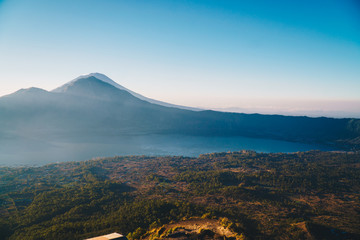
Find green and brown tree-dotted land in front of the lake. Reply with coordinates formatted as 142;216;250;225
0;151;360;240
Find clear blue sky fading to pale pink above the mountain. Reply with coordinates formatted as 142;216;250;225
0;0;360;116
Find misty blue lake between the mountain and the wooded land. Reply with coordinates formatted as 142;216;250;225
0;135;336;166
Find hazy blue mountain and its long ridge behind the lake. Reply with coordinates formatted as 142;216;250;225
0;74;360;165
